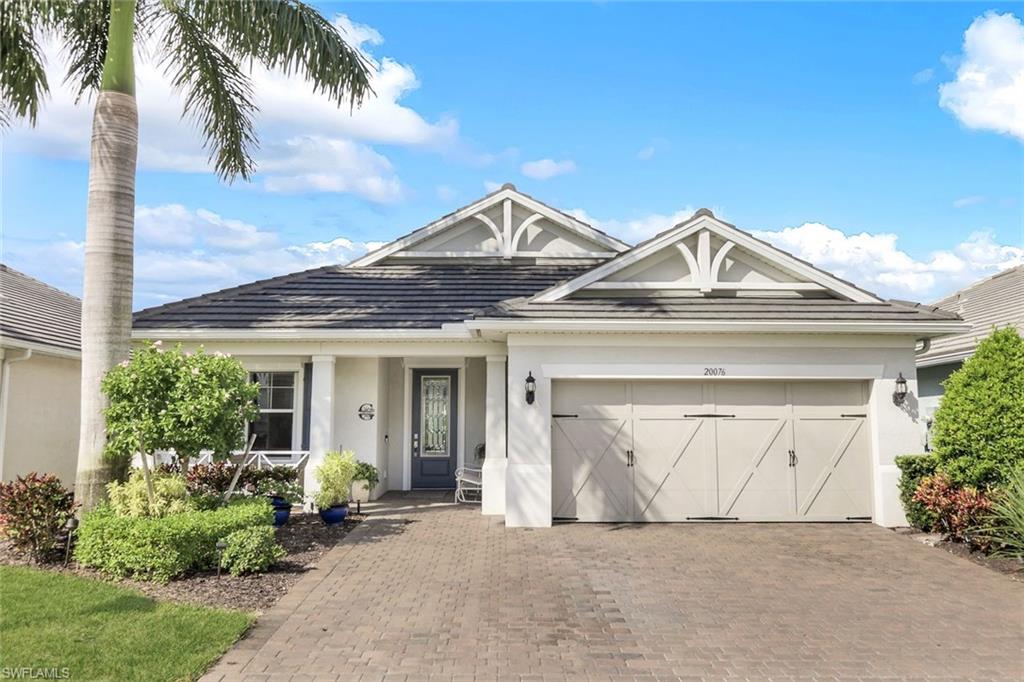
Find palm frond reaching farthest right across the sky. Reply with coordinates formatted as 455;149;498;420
171;0;373;106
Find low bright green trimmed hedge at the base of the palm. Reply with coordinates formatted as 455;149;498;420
75;499;273;583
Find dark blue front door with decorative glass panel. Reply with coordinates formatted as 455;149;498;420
412;370;459;488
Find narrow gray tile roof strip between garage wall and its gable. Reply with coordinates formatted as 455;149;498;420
475;296;957;322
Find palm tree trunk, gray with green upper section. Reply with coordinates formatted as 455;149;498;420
75;0;138;511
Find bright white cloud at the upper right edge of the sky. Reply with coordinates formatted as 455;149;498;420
939;11;1024;140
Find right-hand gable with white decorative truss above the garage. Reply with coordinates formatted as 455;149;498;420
532;209;880;303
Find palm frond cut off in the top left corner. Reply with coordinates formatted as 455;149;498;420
0;0;49;127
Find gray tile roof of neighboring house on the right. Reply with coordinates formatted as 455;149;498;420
918;265;1024;367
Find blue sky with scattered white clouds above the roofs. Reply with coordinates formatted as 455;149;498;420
2;3;1024;308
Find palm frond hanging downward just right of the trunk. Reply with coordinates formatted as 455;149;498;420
163;3;257;179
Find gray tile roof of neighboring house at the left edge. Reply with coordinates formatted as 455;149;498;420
0;263;82;354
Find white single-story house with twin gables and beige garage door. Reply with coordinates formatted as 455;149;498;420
133;184;965;526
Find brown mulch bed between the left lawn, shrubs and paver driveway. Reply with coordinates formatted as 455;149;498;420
0;511;365;613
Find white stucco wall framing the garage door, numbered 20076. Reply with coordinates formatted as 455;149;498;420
506;334;921;526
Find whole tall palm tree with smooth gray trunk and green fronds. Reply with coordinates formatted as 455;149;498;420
0;0;373;509
